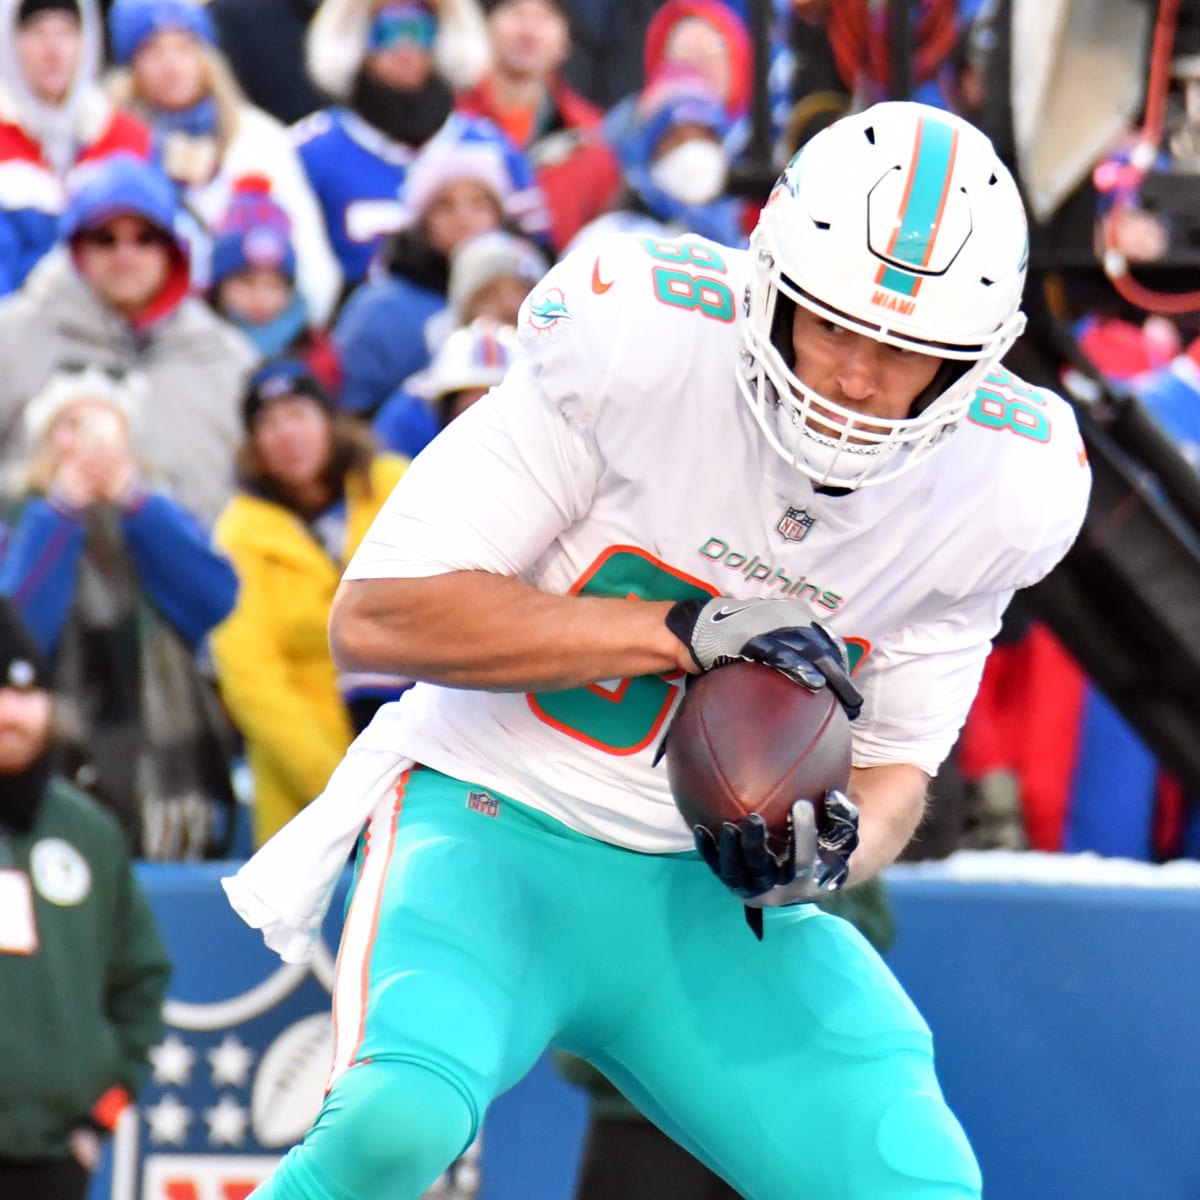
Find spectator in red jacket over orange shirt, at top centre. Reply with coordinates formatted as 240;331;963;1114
455;0;620;252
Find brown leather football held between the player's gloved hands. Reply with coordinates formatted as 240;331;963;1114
666;662;851;835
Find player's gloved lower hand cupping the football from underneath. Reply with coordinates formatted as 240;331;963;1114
692;788;858;908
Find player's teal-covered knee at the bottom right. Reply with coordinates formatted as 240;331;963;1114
856;1092;983;1200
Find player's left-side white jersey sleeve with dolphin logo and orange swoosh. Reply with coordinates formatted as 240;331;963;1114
346;235;733;578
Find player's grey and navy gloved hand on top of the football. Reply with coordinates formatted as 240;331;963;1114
666;596;863;720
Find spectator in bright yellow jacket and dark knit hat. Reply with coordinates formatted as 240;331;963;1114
211;360;407;845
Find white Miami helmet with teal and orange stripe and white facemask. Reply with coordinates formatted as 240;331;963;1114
738;101;1028;488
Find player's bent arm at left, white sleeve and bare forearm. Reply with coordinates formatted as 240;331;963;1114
330;247;696;691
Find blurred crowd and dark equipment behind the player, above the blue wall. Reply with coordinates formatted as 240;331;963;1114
0;0;1200;860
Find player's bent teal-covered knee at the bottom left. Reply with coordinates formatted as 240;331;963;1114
308;1060;476;1198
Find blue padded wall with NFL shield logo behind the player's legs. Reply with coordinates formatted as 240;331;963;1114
89;856;1200;1200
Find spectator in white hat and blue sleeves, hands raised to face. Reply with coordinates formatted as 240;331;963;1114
0;365;238;859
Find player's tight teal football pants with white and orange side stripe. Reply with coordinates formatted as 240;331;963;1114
254;769;980;1200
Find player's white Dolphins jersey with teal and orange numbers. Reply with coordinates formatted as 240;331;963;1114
346;236;1090;852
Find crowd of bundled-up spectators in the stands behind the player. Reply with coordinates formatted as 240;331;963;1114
0;0;1198;902
